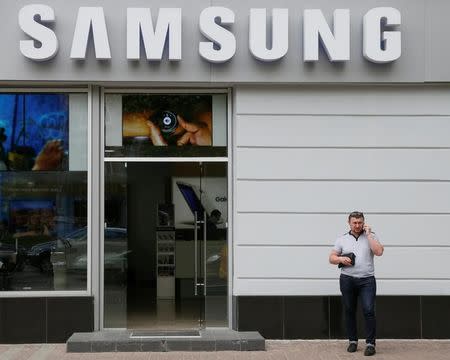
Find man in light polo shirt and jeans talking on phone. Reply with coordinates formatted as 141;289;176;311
329;211;384;356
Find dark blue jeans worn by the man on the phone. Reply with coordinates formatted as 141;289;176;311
339;274;377;345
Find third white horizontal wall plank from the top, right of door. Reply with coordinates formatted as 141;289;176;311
236;148;450;181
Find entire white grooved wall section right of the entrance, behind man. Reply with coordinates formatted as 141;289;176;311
233;85;450;295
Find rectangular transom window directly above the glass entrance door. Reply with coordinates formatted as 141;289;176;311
105;94;227;157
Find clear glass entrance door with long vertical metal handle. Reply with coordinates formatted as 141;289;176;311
103;161;228;330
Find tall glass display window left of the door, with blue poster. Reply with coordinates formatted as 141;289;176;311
0;93;88;292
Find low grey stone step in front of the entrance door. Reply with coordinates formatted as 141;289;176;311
66;328;266;353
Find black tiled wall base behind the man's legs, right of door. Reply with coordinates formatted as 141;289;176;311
233;296;450;339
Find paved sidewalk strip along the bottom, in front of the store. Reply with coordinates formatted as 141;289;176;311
0;340;450;360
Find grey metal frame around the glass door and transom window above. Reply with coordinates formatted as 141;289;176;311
96;86;233;330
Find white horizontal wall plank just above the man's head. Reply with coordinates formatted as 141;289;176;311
236;181;450;213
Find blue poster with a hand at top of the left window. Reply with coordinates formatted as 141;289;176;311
0;93;69;171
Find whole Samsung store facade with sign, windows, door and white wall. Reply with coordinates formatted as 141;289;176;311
0;0;450;343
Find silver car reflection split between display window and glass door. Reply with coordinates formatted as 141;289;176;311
51;227;129;271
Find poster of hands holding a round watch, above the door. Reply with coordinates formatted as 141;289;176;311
122;94;213;147
